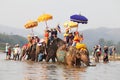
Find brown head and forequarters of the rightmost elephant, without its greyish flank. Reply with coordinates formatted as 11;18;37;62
66;46;89;66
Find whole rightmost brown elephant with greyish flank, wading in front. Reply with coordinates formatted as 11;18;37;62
57;46;90;66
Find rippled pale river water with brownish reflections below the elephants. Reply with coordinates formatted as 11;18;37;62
0;53;120;80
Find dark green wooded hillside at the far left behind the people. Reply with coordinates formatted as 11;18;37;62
0;33;27;50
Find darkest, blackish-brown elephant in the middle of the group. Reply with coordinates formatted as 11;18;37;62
46;38;65;62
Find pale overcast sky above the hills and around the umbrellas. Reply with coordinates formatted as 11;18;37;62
0;0;120;32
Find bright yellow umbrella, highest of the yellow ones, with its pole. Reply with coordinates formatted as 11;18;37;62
37;14;53;28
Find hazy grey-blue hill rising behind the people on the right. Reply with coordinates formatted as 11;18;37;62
81;27;120;46
